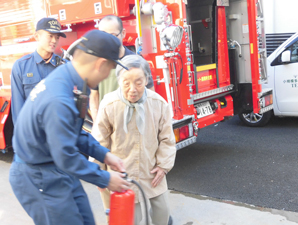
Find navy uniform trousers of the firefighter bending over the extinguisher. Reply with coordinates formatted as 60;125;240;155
9;160;95;225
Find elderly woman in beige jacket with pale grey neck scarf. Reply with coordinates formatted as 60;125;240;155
92;55;176;225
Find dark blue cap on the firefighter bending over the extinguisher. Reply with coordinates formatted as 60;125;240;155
77;30;128;70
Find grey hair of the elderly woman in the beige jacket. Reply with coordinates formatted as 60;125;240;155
116;55;151;81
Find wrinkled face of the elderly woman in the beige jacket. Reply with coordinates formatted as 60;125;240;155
119;68;147;103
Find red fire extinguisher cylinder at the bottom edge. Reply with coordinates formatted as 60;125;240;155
109;190;135;225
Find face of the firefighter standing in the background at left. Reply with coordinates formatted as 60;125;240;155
35;30;60;53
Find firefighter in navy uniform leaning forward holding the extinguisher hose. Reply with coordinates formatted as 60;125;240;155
9;30;129;225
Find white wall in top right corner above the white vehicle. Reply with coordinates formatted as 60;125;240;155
263;0;298;34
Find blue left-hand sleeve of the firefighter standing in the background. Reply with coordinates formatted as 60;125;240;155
11;61;26;124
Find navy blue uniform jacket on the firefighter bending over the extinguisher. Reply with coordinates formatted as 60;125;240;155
13;62;110;188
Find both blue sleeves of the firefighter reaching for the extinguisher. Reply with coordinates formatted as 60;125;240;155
42;99;110;188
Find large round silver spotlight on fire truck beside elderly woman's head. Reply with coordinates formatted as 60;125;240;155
160;24;183;51
